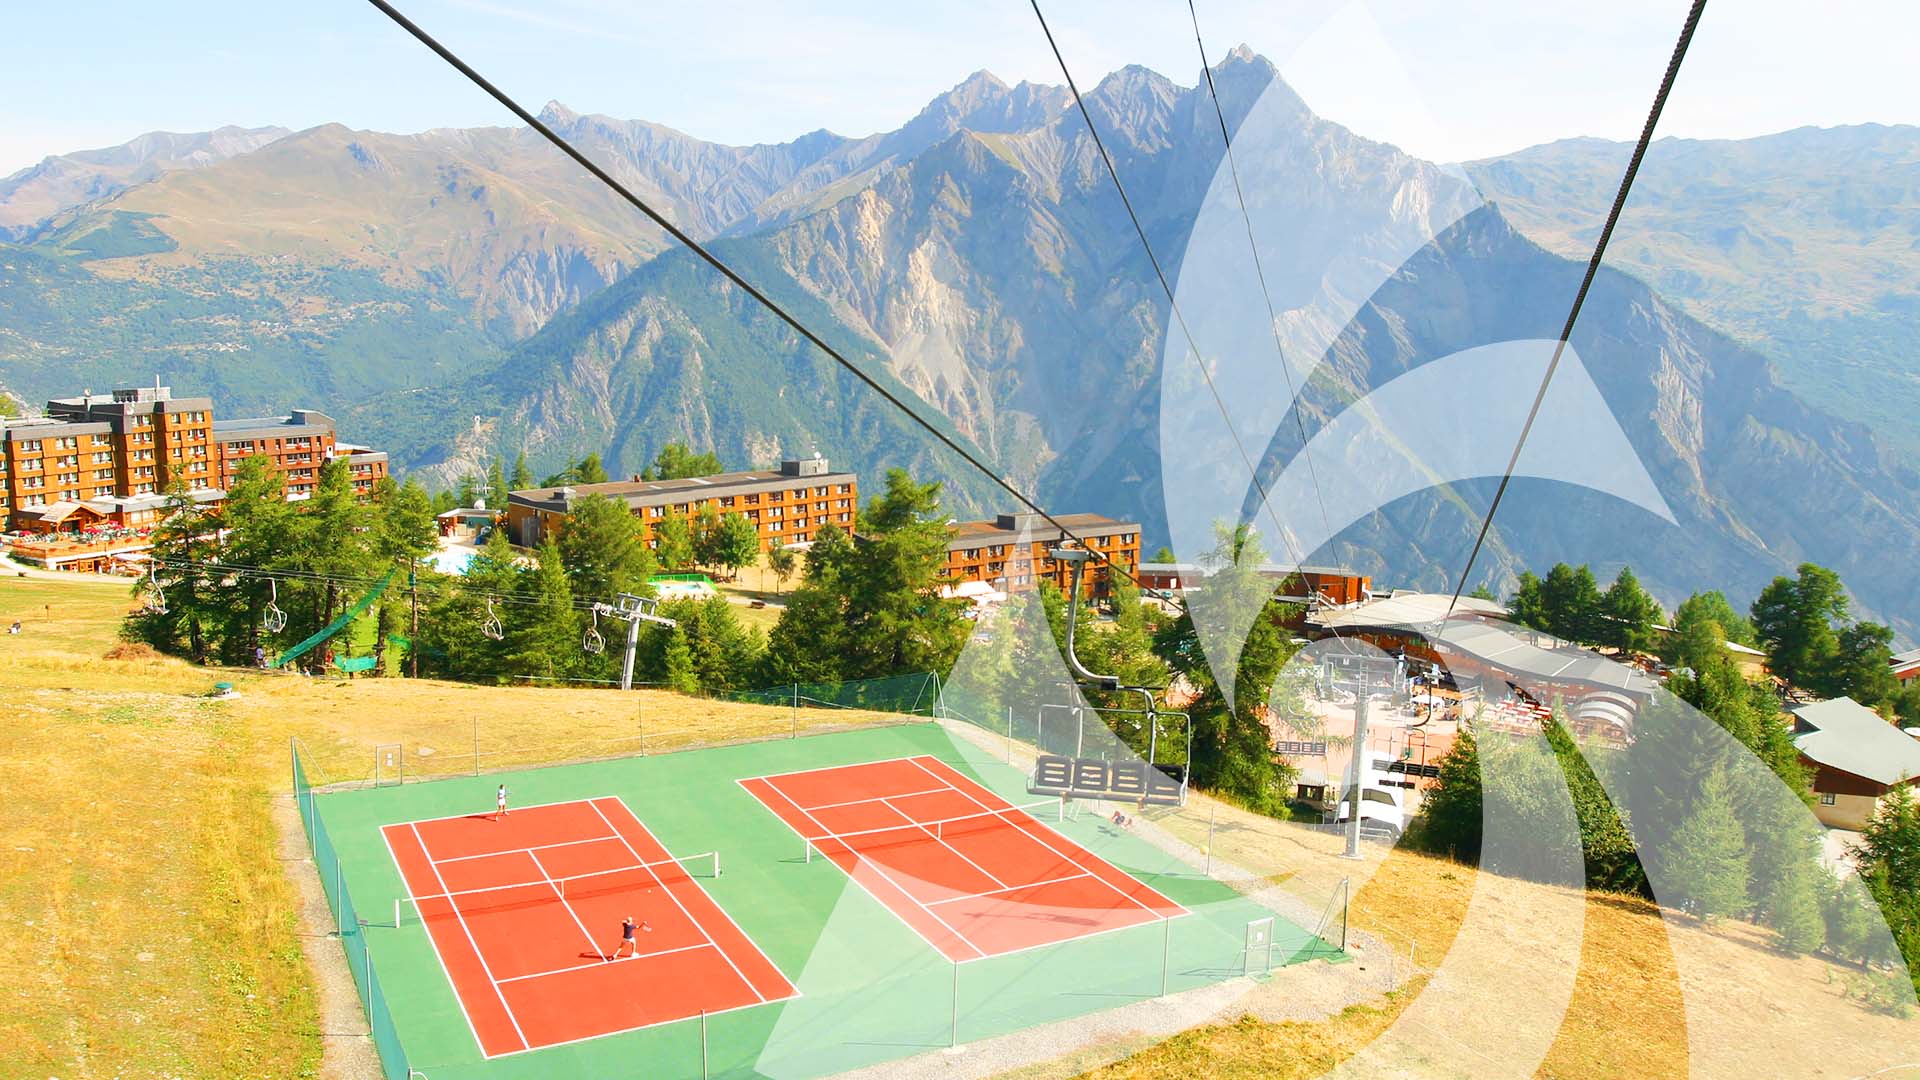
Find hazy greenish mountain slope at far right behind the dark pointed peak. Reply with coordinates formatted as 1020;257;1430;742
1469;125;1920;455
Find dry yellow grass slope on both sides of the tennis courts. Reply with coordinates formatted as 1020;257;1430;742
0;578;1920;1080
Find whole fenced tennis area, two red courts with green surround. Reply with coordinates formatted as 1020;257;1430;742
307;723;1336;1080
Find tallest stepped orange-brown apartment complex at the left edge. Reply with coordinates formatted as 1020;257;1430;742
0;386;388;532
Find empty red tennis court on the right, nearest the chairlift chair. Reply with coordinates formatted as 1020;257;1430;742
741;757;1187;963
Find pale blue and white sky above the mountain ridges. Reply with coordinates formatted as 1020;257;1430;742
0;0;1920;175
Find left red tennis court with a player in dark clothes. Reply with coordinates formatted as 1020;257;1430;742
382;798;795;1057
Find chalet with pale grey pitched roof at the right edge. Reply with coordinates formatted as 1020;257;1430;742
1793;698;1920;828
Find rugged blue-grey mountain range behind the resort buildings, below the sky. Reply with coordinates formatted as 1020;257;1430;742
0;48;1920;634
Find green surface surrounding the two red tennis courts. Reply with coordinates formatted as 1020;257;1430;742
303;723;1334;1080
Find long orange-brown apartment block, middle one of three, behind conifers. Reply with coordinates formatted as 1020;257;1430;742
507;457;860;552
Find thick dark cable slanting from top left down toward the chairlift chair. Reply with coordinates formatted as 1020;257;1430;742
367;0;1140;586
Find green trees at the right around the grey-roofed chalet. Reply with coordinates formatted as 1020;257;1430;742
1407;563;1920;1003
